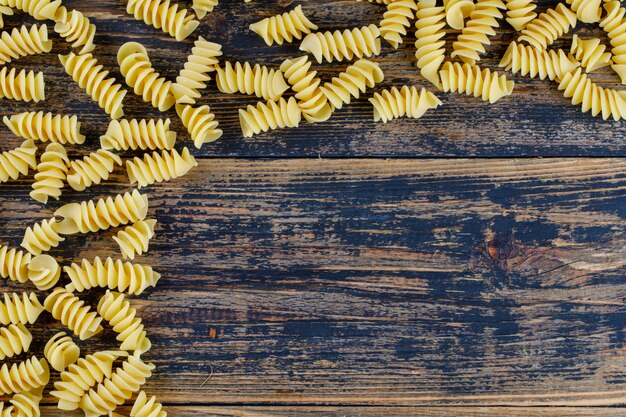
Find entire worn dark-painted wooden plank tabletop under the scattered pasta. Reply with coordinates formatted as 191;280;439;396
0;0;626;417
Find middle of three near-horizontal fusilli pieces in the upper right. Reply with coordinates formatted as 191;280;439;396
499;42;580;81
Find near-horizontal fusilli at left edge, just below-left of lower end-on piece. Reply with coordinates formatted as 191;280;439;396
0;356;50;394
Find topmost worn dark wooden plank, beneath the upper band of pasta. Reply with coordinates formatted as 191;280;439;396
0;0;626;157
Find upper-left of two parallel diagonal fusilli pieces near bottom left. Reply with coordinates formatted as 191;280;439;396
50;350;128;411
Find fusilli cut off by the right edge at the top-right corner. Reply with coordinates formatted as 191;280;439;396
600;0;626;84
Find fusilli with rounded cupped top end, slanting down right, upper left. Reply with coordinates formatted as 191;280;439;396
117;42;176;111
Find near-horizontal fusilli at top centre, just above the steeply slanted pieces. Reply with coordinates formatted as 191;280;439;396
300;25;381;64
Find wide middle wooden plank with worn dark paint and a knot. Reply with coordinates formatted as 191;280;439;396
0;159;626;406
